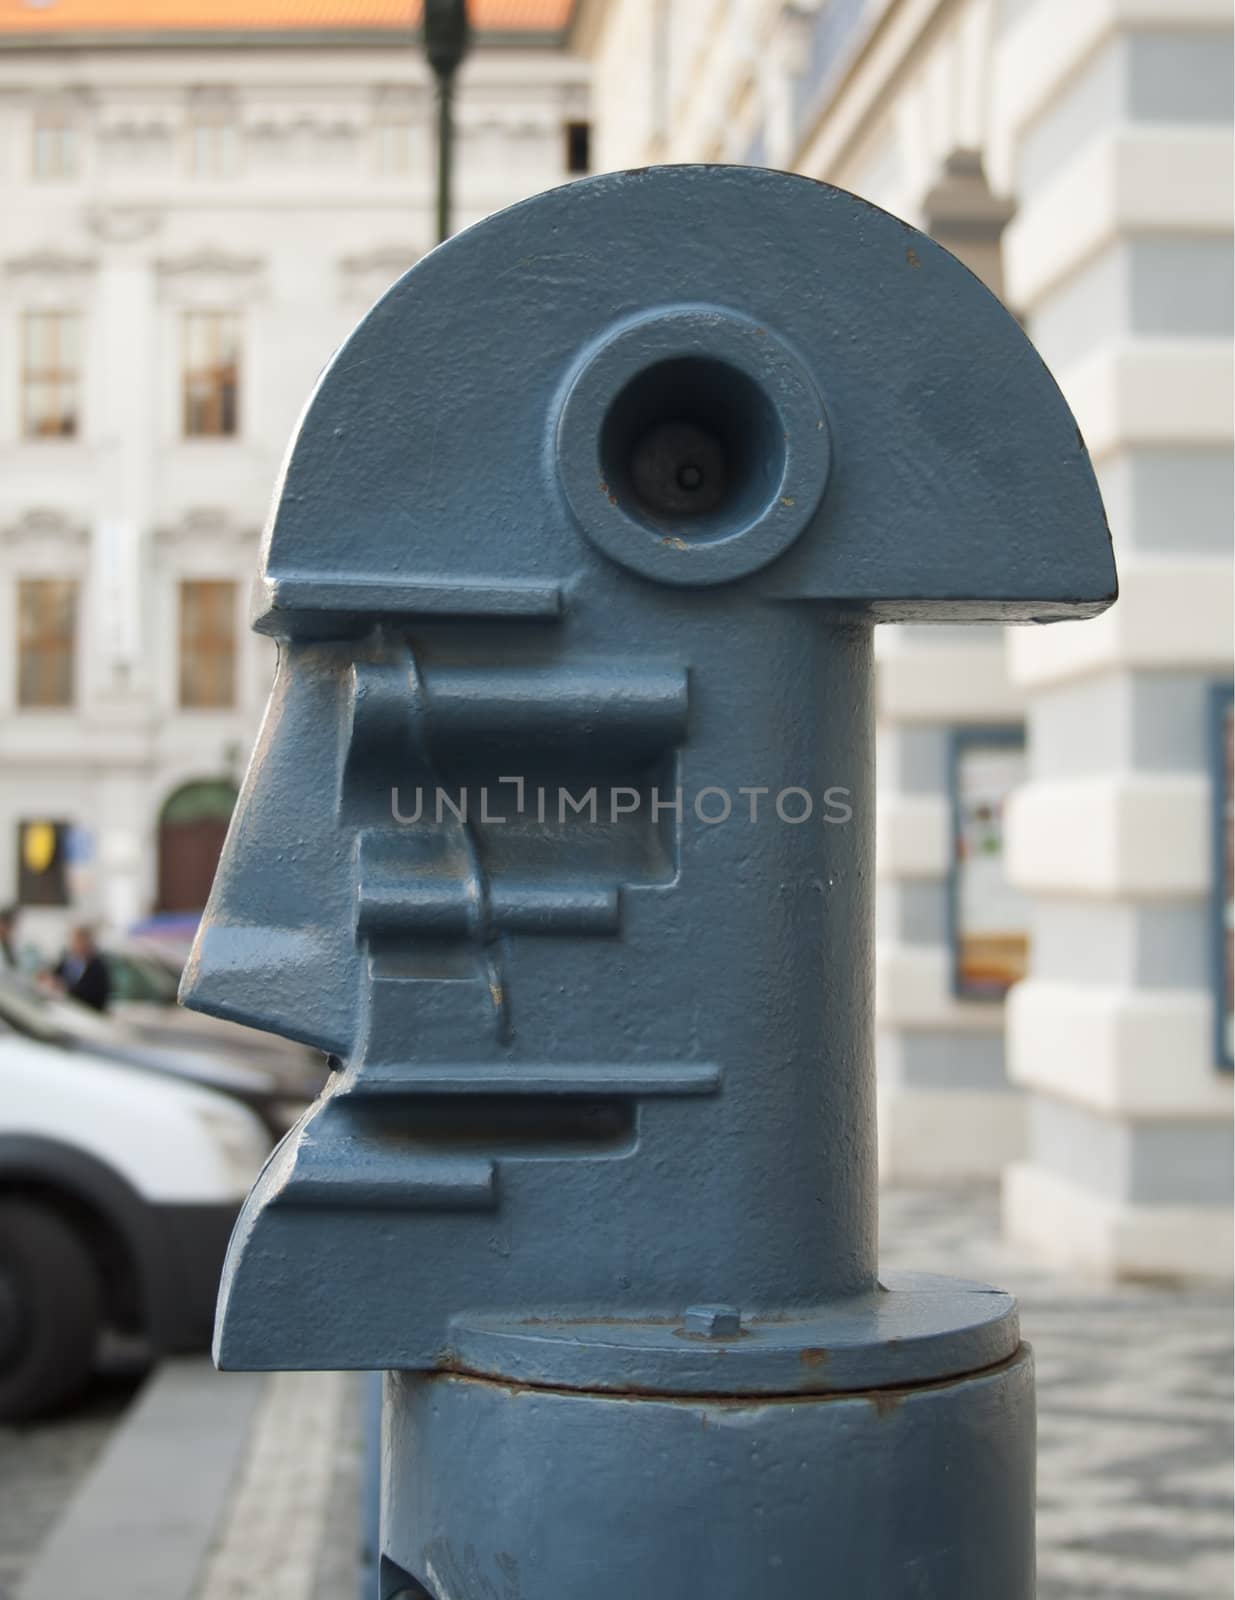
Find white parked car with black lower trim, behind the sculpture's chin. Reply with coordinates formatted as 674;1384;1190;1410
0;979;272;1421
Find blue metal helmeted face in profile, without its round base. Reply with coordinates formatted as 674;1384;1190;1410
184;168;1115;1382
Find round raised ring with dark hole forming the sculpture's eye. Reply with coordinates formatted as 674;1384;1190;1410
557;306;830;584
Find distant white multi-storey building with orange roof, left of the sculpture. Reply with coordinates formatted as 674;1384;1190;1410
0;0;589;942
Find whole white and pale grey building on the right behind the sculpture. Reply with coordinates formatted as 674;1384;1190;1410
573;0;1232;1275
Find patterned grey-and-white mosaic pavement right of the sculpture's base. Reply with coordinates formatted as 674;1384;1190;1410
881;1186;1232;1600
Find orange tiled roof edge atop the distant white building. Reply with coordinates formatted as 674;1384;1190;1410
0;0;573;37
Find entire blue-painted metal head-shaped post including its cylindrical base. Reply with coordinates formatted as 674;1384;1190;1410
186;168;1115;1600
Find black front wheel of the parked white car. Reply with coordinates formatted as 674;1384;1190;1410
0;1200;102;1422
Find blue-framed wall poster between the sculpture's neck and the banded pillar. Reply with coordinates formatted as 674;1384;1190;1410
949;728;1029;1000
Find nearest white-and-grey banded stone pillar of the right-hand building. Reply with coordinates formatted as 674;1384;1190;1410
992;0;1232;1275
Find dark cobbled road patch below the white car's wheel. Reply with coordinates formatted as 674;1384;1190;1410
0;1362;142;1600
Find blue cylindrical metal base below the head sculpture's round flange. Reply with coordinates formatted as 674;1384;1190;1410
382;1346;1033;1600
